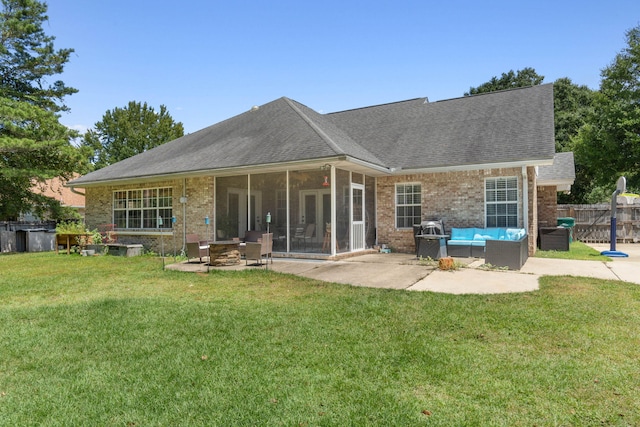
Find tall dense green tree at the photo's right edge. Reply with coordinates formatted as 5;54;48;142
575;26;640;198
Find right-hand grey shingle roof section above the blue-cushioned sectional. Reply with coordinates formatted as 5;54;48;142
328;84;555;169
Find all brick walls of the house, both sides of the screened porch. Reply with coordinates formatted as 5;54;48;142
85;168;544;254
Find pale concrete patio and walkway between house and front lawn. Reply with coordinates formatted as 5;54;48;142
167;244;640;294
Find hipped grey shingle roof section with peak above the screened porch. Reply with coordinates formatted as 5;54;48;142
73;97;382;185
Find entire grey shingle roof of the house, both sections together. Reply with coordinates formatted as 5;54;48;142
71;85;554;187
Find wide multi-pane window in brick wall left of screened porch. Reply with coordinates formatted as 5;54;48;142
113;188;173;229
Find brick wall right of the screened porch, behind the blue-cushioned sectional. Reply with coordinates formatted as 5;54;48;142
377;168;537;254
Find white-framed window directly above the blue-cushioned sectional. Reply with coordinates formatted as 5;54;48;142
484;177;519;227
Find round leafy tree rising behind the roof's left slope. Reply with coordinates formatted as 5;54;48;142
82;101;184;169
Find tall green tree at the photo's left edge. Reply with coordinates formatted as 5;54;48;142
0;0;87;220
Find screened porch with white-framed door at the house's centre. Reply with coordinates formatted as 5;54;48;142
212;165;375;256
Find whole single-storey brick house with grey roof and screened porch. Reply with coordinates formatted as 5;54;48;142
68;85;556;256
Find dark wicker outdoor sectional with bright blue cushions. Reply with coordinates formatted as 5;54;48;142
447;228;529;270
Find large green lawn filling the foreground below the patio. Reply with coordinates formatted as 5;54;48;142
0;254;640;426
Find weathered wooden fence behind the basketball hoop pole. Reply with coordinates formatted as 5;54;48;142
558;201;640;243
